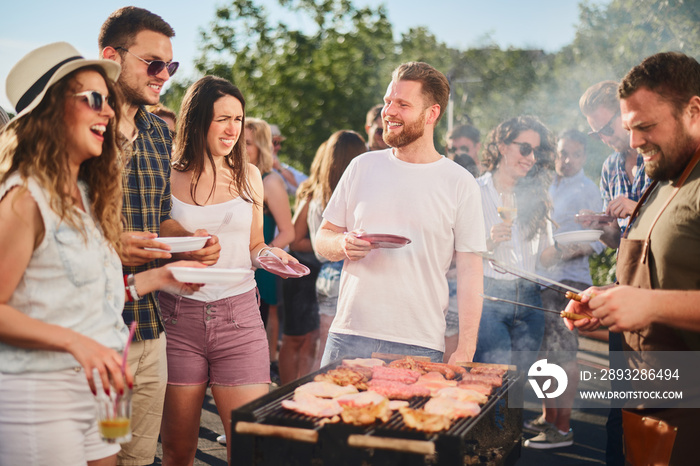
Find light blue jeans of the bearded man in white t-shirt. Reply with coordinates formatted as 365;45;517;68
321;333;443;366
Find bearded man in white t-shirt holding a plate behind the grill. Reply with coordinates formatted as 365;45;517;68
316;62;486;365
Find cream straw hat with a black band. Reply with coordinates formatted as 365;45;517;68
5;42;121;118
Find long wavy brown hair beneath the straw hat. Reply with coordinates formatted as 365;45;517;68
0;66;122;251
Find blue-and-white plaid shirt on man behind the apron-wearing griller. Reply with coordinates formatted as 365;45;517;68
600;152;651;233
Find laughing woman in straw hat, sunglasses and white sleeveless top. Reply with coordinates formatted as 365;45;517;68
0;42;198;465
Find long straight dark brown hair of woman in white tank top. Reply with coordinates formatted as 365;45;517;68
173;76;253;205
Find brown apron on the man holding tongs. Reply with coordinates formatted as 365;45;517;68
617;147;700;465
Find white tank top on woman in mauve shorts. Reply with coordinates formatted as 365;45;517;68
172;196;255;302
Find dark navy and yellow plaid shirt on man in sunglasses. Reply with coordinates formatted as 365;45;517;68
122;107;172;341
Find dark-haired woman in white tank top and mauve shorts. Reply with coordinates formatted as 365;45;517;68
159;76;296;465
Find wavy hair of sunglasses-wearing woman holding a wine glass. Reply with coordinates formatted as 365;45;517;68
482;115;556;240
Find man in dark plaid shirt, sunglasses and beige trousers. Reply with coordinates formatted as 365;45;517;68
99;7;221;465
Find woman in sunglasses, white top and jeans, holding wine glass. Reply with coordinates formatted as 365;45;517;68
474;116;560;370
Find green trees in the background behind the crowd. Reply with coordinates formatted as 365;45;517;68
164;0;700;284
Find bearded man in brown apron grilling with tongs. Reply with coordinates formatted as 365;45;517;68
567;52;700;465
